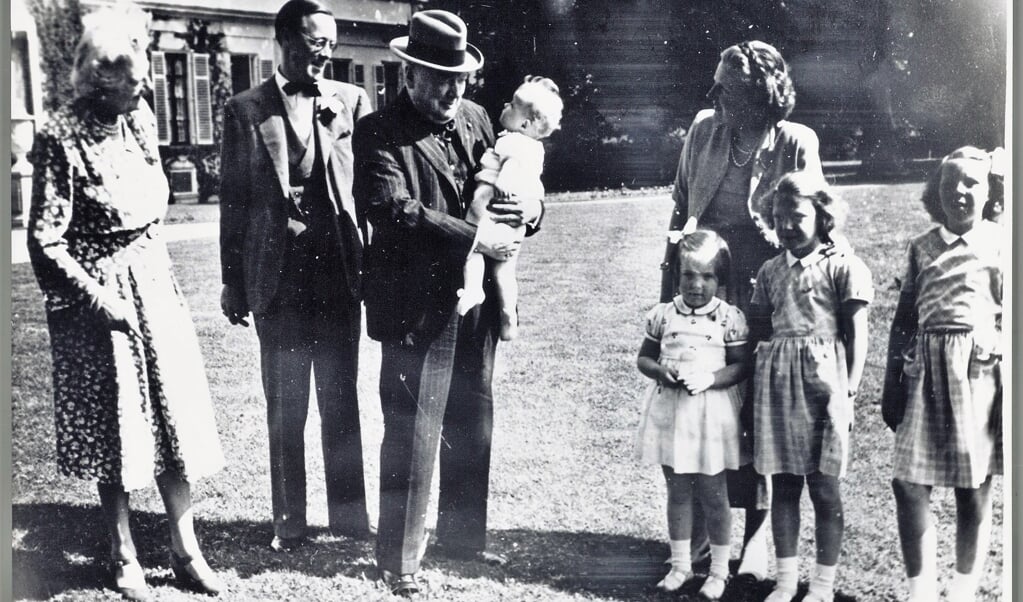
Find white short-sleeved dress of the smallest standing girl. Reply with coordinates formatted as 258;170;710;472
635;296;749;475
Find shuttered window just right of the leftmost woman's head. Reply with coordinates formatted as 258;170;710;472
150;51;213;144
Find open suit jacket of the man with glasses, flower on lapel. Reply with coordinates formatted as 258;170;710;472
220;78;369;323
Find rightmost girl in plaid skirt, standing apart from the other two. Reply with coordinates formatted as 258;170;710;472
882;147;1008;602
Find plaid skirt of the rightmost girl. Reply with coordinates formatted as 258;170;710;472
894;332;1003;488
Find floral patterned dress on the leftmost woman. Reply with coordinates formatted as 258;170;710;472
29;101;224;490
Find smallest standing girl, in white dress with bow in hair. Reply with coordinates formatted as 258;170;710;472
636;230;749;600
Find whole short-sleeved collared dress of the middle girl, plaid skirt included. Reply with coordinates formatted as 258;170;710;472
752;246;874;477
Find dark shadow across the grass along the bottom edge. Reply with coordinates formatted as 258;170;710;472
12;504;855;602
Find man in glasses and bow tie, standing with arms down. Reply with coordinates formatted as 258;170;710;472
220;0;370;552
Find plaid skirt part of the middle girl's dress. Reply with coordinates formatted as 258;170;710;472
753;336;852;477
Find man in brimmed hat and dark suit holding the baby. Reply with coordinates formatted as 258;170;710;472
353;10;542;595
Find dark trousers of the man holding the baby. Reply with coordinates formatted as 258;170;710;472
376;311;496;573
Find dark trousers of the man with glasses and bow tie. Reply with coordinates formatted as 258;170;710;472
256;231;369;538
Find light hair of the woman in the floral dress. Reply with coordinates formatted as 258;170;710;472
71;4;149;98
